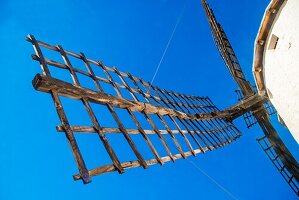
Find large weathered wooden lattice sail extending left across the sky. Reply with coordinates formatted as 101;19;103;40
27;35;241;183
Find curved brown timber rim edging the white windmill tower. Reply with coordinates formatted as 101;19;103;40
252;0;288;96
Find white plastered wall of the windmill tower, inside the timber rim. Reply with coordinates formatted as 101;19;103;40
264;0;299;143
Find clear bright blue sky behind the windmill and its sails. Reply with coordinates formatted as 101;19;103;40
0;0;299;200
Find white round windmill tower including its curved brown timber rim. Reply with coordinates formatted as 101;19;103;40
253;0;299;143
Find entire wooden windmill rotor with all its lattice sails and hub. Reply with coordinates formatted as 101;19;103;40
27;0;299;194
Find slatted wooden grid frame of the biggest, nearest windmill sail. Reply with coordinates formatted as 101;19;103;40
27;35;241;183
